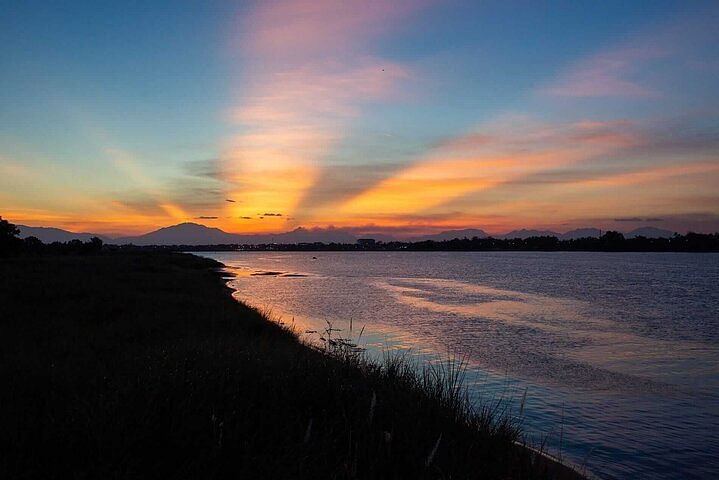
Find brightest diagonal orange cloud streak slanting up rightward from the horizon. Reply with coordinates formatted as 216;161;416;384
325;116;638;221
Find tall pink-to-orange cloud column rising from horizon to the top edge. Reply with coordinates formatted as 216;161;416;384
223;0;417;230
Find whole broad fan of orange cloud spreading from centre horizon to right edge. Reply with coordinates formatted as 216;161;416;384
302;110;719;231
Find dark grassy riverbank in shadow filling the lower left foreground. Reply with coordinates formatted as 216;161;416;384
0;253;574;479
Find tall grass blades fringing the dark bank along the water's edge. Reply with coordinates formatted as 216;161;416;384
278;311;581;478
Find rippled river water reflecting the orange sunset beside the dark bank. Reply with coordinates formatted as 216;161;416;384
201;252;719;479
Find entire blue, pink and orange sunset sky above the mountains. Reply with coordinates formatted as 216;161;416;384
0;0;719;237
